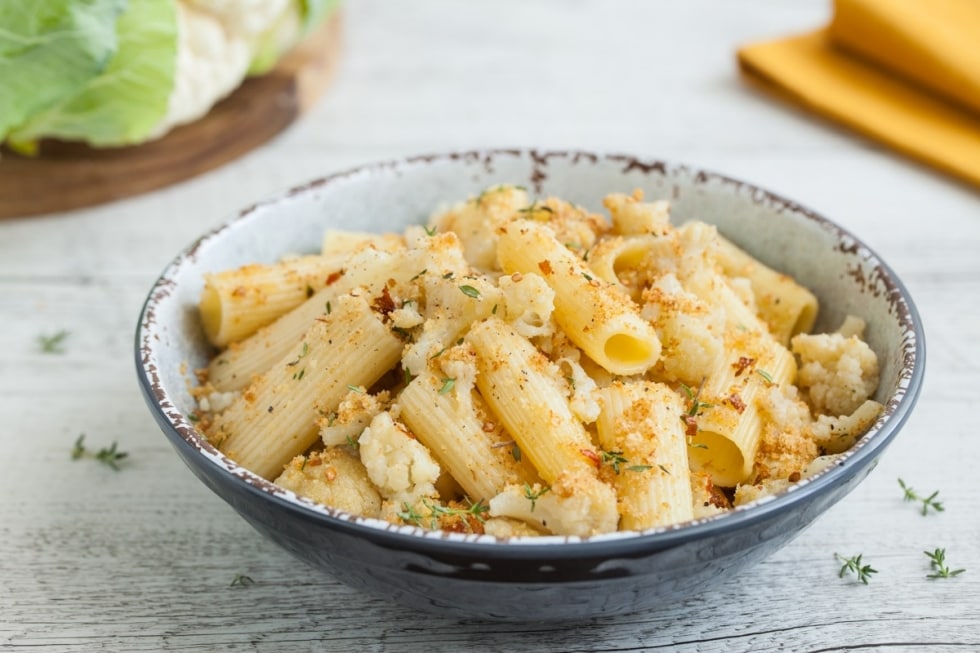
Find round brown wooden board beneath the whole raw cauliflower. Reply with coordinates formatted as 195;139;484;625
0;12;341;218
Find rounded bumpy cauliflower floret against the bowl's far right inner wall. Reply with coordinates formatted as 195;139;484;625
791;333;878;416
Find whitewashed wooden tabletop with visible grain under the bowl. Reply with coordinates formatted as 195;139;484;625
0;0;980;652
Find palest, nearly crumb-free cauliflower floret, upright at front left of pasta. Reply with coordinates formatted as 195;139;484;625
358;413;440;505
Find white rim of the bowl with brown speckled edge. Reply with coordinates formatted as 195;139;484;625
136;148;925;560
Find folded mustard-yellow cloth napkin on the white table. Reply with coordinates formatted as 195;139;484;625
738;0;980;186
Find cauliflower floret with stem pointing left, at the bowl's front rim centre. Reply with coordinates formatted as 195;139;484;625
490;472;619;537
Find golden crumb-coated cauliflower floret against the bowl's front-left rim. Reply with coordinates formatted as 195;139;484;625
275;447;381;517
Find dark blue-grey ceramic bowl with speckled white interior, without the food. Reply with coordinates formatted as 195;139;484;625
136;150;925;621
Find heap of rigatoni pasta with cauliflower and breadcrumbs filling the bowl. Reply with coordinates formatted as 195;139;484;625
195;185;881;536
